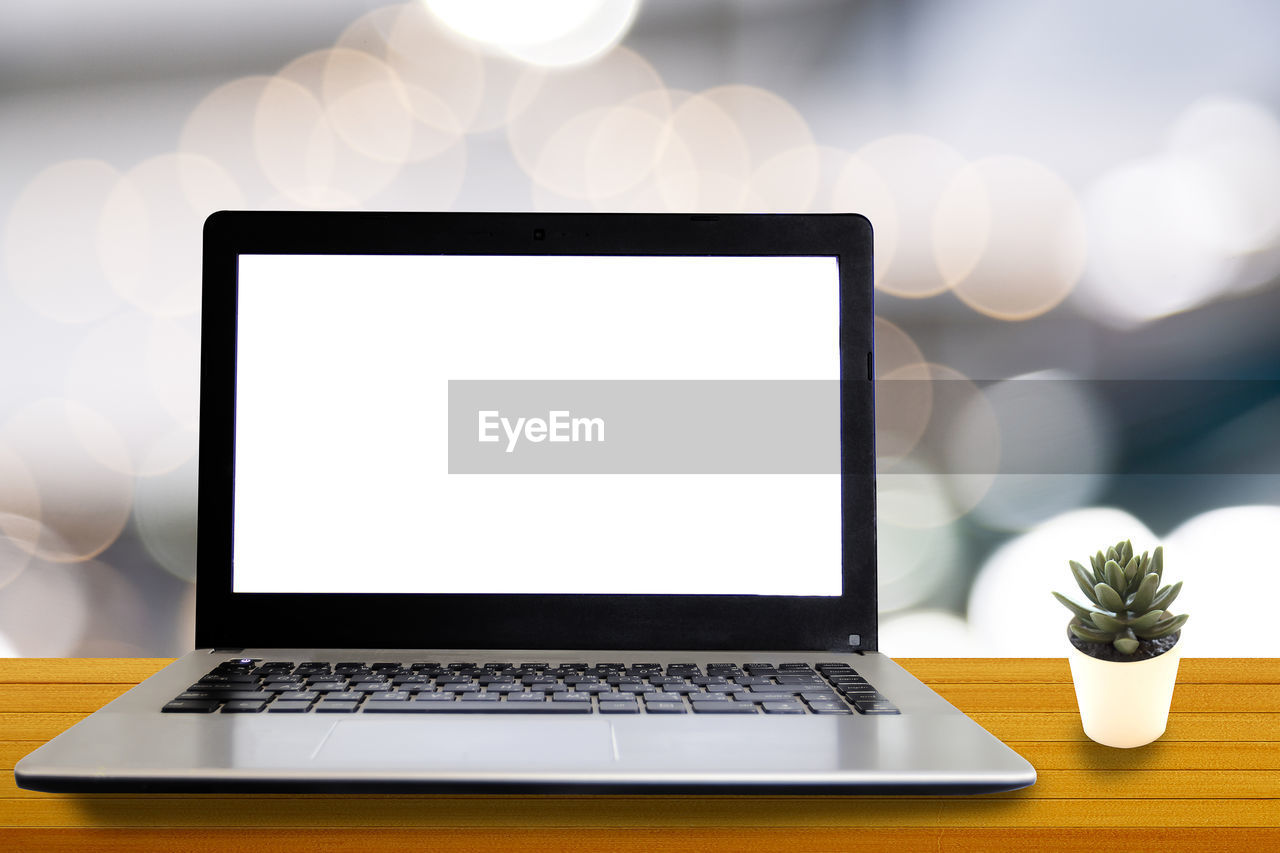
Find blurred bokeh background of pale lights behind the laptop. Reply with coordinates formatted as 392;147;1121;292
0;0;1280;656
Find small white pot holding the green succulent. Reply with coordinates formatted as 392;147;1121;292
1068;637;1183;748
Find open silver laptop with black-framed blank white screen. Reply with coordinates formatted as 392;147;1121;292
15;211;1036;793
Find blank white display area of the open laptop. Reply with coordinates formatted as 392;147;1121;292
232;254;842;597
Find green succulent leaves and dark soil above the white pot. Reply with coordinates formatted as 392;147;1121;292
1053;539;1187;654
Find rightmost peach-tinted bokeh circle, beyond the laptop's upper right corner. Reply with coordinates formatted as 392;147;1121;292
933;156;1085;320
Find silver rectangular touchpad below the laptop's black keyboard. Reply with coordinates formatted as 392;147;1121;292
312;716;617;771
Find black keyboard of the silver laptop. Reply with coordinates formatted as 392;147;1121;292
163;658;899;715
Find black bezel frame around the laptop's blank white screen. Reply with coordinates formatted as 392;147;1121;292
196;211;877;651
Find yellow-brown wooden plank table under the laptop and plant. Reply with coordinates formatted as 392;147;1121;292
0;658;1280;853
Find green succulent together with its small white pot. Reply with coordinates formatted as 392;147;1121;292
1053;539;1187;747
